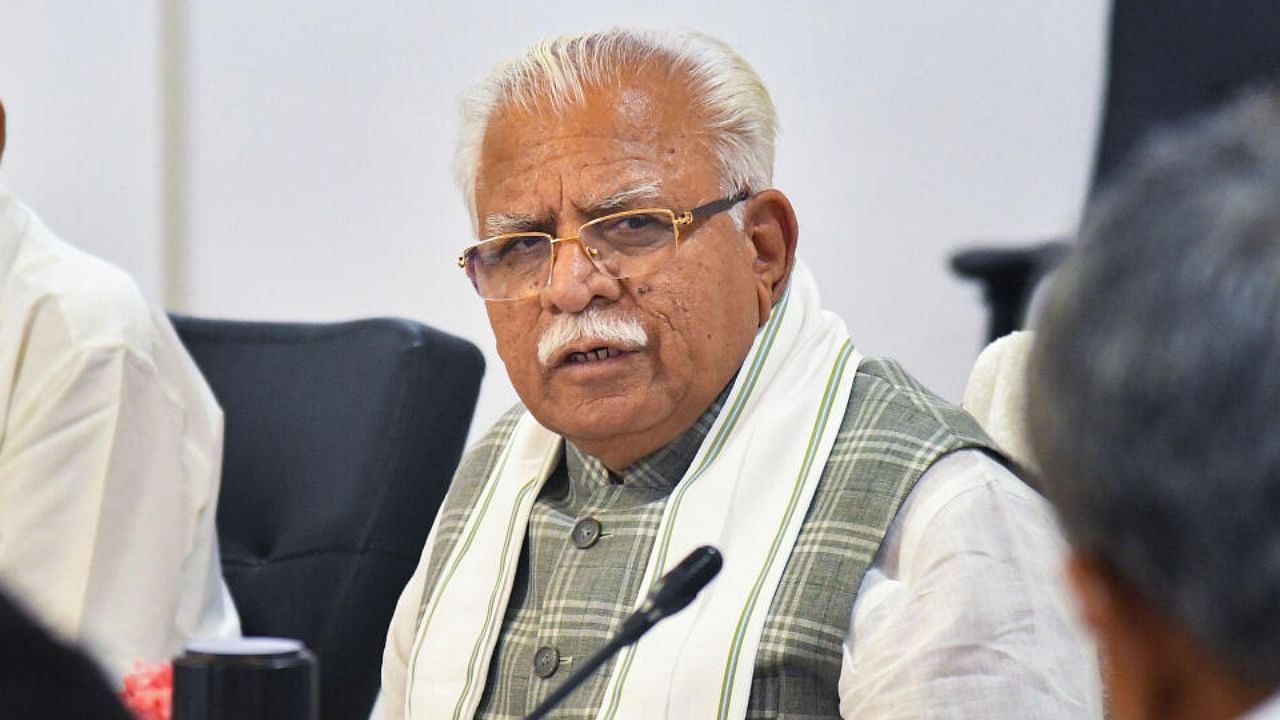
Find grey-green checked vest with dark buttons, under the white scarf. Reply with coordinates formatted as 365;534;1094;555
419;359;995;720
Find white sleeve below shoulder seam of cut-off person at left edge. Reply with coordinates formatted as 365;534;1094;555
0;338;196;680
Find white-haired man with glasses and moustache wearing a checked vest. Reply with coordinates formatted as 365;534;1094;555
384;31;1098;720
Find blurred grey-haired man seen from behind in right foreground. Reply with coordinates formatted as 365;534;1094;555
1030;91;1280;720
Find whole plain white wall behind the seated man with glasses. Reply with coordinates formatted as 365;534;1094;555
0;0;1106;438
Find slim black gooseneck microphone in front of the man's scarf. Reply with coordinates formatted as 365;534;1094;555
525;544;724;720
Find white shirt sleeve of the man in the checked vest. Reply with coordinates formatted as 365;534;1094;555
840;450;1102;720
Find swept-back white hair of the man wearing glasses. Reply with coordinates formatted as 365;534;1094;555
456;28;777;225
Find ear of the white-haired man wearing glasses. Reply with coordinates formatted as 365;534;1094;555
742;190;799;325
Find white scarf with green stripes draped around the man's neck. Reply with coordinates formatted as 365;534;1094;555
406;261;860;720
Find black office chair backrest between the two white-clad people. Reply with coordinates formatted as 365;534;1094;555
173;316;484;720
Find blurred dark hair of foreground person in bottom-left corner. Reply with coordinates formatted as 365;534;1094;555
0;584;133;720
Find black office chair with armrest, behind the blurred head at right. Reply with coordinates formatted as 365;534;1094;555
951;0;1280;342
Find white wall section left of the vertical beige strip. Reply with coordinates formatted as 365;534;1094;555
0;0;164;297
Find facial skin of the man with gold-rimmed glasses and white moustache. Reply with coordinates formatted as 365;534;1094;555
476;74;762;470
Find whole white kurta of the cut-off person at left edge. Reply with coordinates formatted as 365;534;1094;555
0;188;239;682
